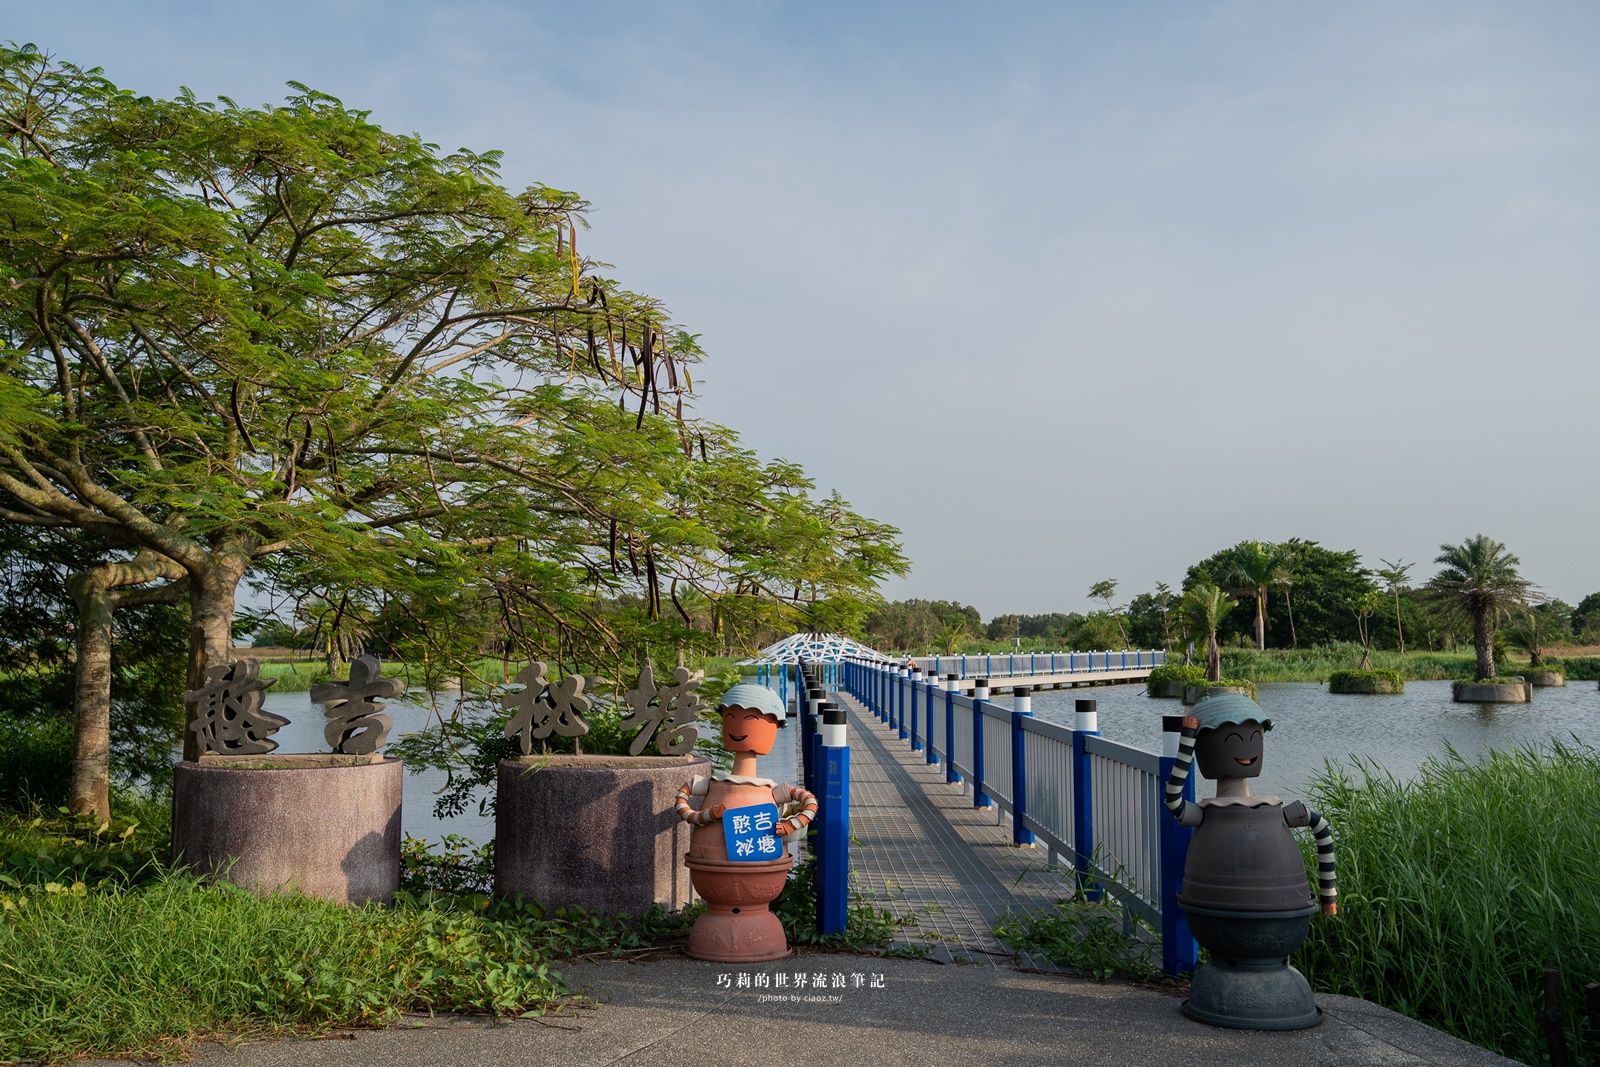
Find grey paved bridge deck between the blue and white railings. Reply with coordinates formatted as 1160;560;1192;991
830;693;1070;969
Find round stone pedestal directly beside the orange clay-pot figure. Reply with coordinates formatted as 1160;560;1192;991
494;755;710;915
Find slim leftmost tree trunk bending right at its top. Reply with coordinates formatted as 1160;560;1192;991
67;550;184;822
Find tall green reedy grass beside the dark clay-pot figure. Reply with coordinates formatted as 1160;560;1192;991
1294;745;1600;1064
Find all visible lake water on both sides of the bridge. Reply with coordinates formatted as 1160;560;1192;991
256;681;1600;841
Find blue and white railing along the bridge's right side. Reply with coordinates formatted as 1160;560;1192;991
840;651;1198;976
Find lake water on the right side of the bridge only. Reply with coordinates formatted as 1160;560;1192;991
1024;681;1600;798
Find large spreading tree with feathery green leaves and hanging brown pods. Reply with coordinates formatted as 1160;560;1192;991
0;48;904;780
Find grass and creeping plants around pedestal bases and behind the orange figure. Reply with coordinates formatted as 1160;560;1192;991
0;803;902;1064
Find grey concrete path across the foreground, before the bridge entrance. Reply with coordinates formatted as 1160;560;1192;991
128;953;1510;1067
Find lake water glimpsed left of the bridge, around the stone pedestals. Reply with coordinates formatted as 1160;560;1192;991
266;693;812;843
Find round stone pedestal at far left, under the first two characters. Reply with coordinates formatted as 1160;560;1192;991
173;753;403;904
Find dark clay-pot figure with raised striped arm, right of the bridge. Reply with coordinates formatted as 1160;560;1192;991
1166;693;1338;1030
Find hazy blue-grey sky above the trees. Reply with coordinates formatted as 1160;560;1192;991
12;0;1600;617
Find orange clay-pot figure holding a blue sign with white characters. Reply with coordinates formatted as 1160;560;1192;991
677;685;816;963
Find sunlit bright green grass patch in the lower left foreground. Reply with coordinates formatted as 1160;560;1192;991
0;873;566;1062
